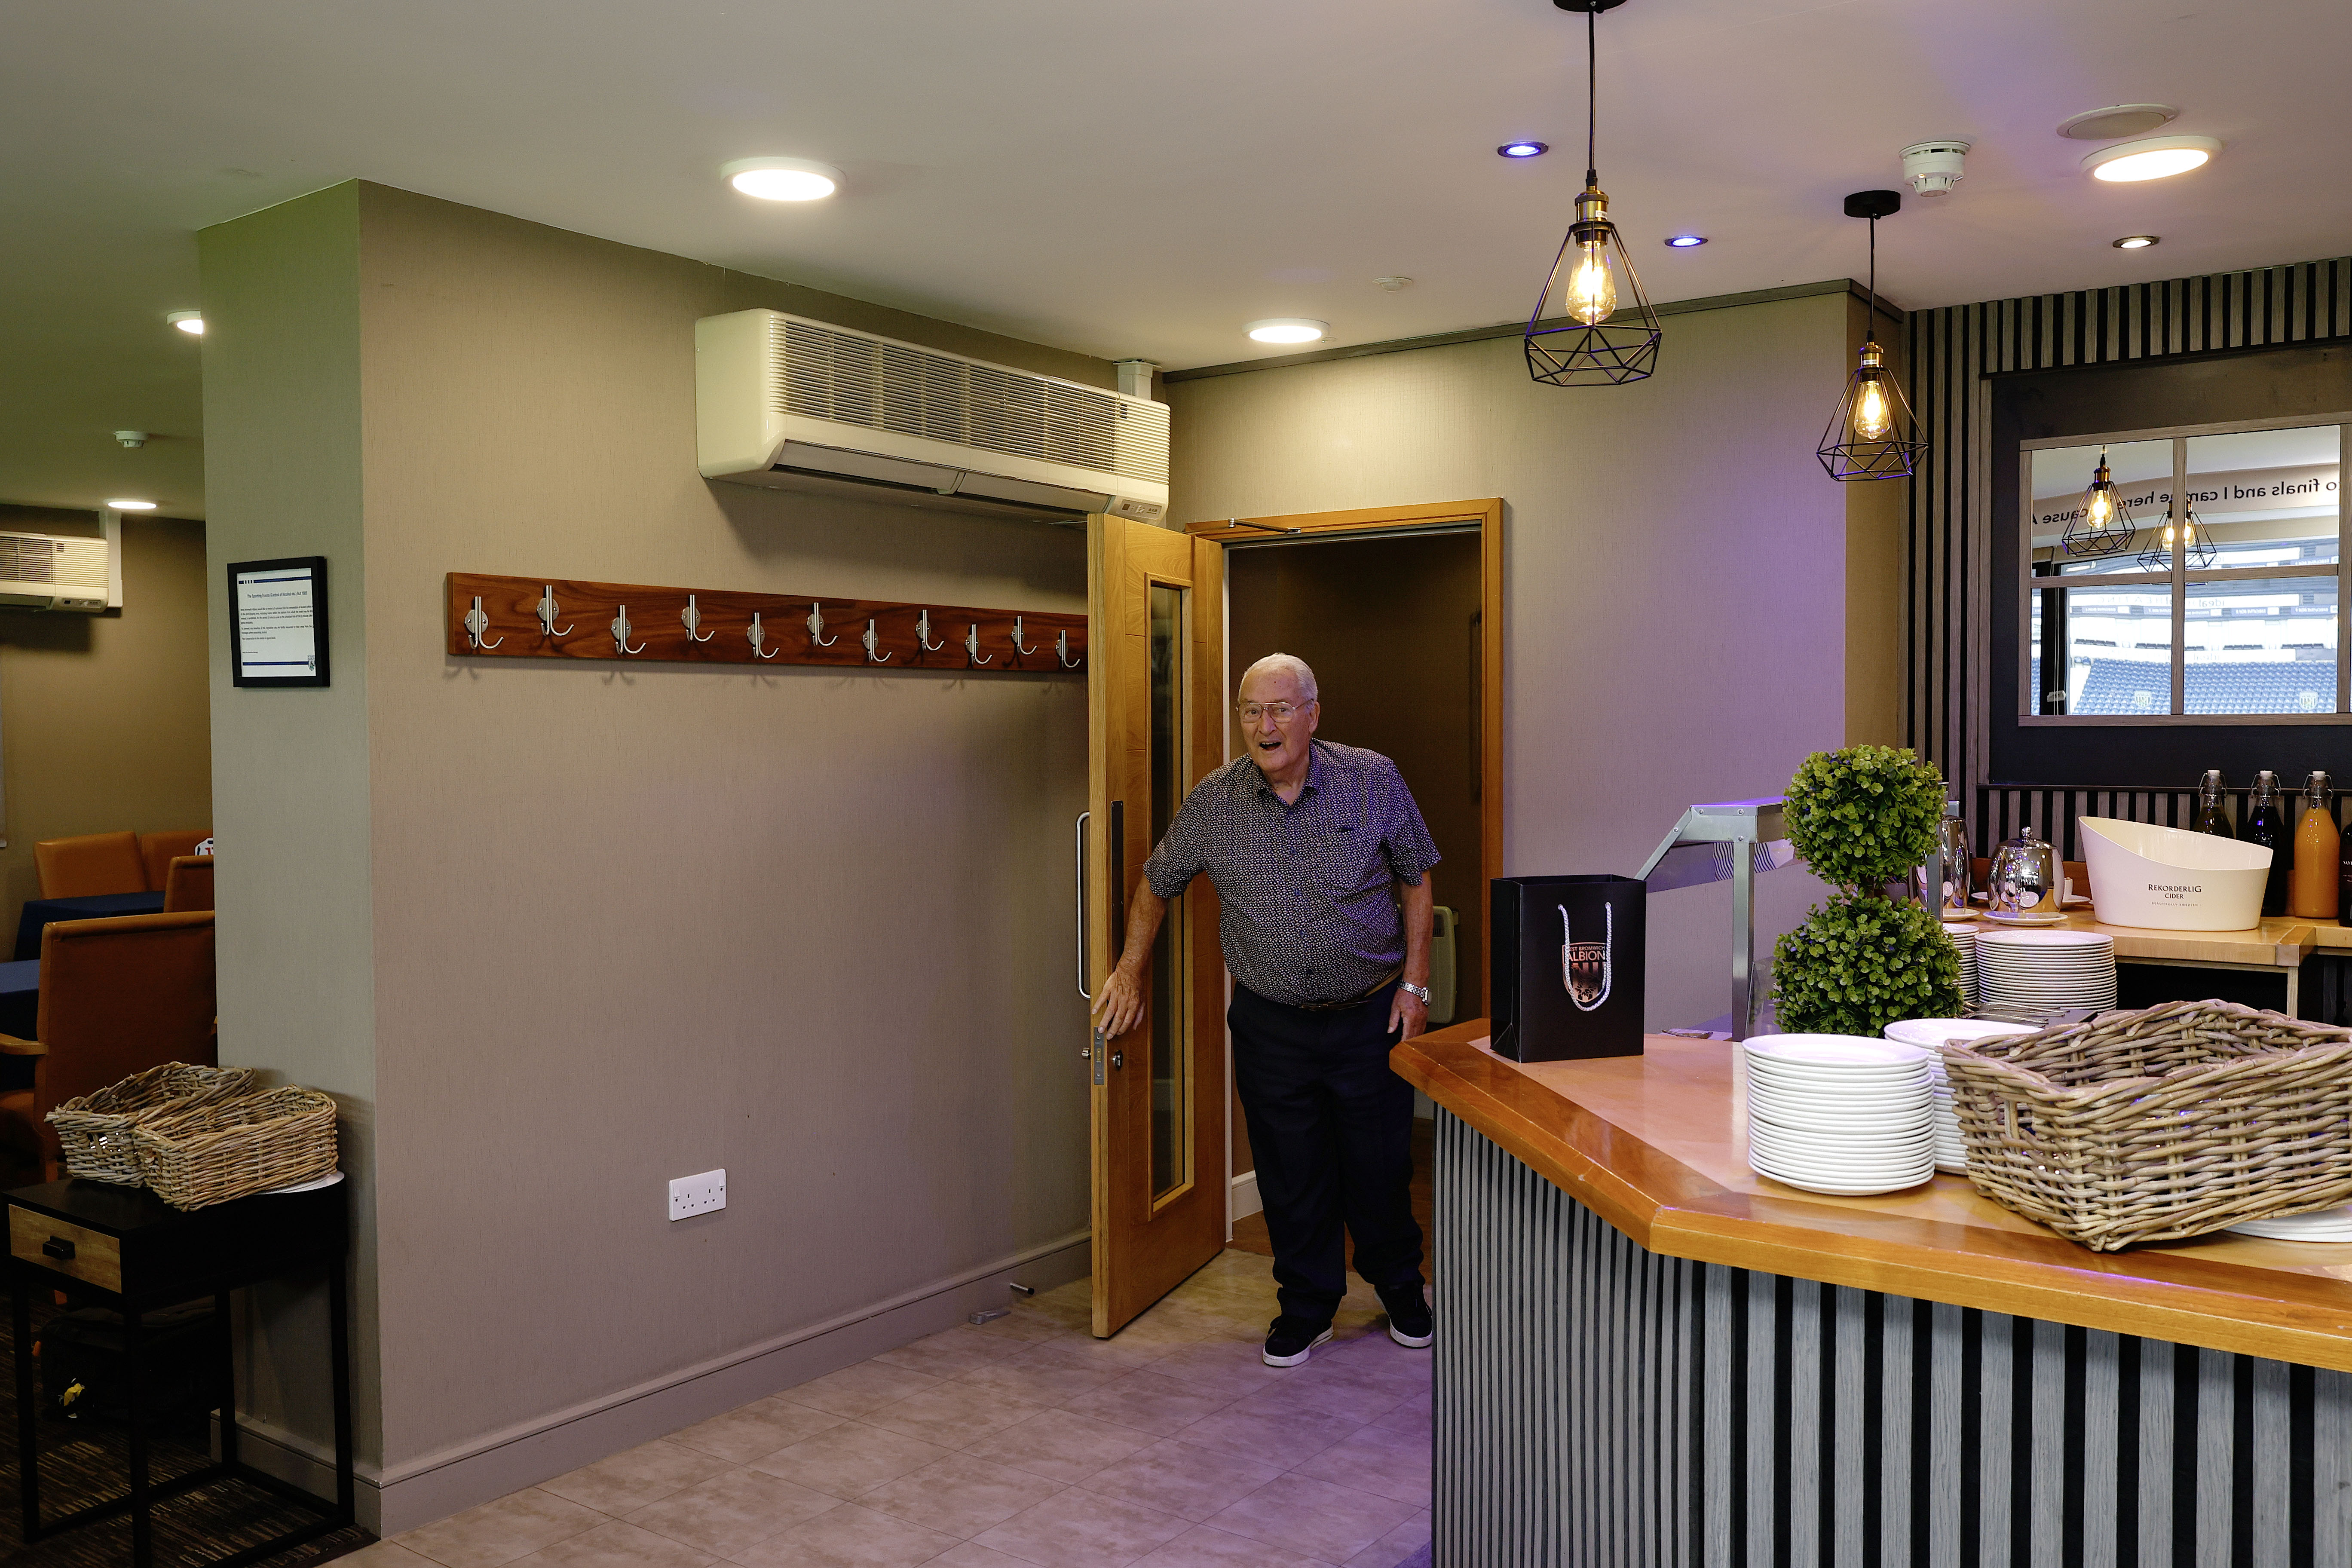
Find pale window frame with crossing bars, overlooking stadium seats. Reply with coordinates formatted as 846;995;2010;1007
2011;411;2352;729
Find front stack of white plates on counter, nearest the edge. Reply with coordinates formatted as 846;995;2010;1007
1740;1034;1936;1194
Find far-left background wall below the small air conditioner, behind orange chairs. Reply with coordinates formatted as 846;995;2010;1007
0;512;211;926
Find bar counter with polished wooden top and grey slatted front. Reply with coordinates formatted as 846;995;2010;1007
1390;1020;2352;1568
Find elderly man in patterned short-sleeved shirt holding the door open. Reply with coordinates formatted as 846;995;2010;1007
1093;653;1437;1366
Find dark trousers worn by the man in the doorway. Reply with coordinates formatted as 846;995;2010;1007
1225;985;1421;1323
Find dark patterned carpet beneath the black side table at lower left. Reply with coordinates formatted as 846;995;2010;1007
0;1300;374;1568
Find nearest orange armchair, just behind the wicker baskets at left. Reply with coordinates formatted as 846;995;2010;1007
0;910;219;1185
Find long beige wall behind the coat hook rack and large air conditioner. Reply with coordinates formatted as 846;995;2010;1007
205;186;1091;1528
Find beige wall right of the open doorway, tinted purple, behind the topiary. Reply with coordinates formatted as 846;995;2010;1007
1169;294;1877;1027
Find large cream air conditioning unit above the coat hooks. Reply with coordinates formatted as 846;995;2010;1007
694;310;1169;522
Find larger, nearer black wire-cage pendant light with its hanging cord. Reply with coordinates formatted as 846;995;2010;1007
1526;0;1665;386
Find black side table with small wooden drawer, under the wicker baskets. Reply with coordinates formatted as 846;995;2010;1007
7;1180;353;1568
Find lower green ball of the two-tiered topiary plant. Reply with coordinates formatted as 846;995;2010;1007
1771;893;1962;1037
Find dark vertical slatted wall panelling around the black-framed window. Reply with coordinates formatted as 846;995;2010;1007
1903;256;2352;783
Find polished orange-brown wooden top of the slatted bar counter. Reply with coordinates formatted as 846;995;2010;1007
1390;1018;2352;1371
